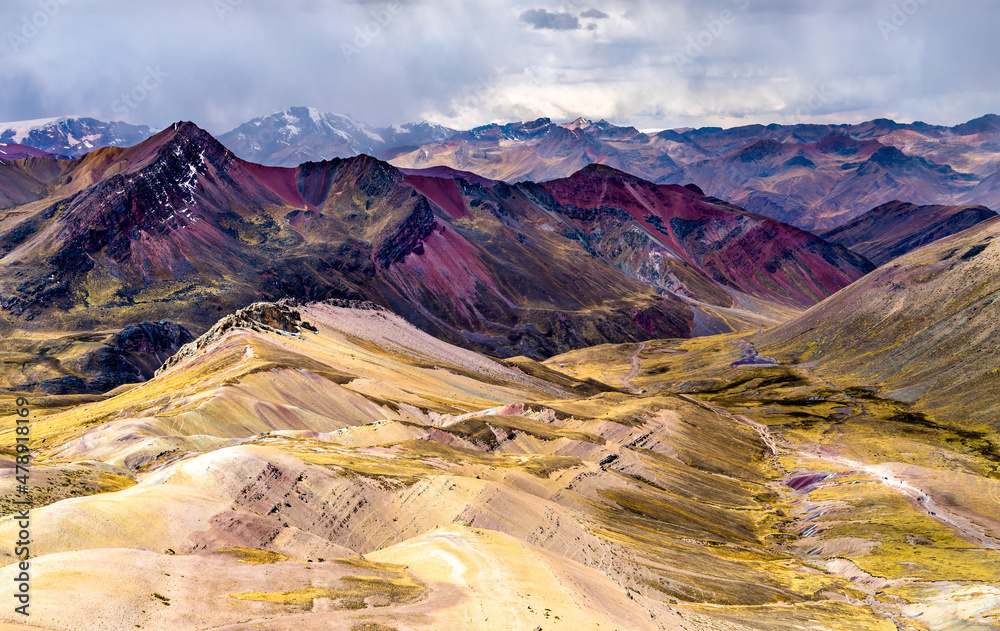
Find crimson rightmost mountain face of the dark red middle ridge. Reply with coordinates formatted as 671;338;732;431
539;165;872;307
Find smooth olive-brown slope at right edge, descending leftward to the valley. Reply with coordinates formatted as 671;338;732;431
758;218;1000;432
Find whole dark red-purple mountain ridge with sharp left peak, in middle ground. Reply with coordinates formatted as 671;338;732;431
0;123;871;390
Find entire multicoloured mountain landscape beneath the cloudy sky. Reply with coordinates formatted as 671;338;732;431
0;110;1000;631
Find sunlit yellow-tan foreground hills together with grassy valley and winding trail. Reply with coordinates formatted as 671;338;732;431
0;290;1000;629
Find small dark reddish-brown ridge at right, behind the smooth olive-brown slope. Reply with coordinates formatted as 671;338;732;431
819;200;997;265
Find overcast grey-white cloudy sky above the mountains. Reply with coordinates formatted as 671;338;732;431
0;0;1000;133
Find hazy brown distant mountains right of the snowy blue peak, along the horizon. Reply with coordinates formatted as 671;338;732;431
392;115;1000;230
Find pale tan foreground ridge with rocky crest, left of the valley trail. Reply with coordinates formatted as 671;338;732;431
0;304;908;631
